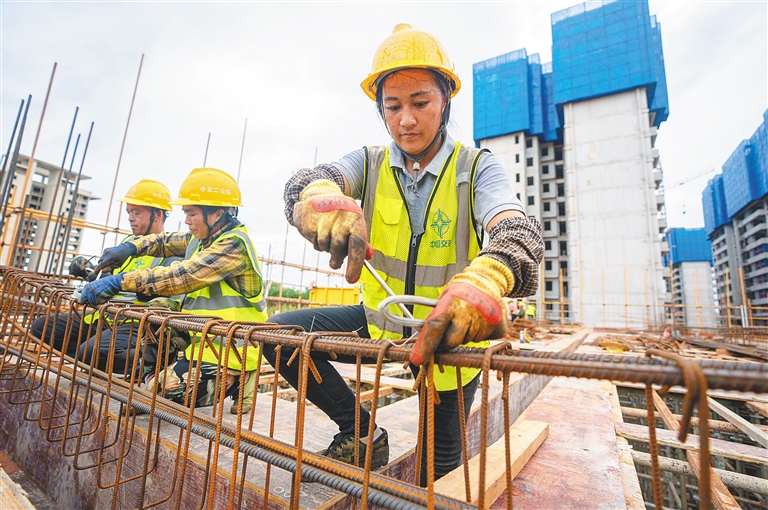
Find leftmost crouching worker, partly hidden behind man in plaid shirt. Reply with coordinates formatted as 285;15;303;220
30;179;181;372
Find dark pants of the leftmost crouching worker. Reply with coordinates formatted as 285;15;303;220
30;313;141;373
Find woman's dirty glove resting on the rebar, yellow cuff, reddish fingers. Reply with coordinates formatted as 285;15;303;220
411;257;515;365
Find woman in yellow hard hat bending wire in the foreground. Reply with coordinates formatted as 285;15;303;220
264;24;544;478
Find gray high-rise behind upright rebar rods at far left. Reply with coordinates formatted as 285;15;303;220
2;154;98;271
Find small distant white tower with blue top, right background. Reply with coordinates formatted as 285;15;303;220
664;228;720;328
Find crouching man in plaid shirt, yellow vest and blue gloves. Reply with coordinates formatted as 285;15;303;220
81;168;267;414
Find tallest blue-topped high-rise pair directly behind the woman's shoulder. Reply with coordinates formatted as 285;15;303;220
473;1;669;327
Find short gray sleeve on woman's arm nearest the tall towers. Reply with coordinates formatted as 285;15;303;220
475;154;525;230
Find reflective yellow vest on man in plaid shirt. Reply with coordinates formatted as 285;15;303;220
181;225;267;372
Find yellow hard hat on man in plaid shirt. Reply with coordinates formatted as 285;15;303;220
171;168;242;207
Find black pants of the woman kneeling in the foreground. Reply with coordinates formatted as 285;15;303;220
263;305;480;486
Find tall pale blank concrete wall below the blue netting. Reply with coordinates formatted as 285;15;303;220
563;89;664;328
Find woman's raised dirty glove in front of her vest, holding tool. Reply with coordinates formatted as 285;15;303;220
293;179;373;283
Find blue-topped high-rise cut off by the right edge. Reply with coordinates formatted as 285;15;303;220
701;111;768;326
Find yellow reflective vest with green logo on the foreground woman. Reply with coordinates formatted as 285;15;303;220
360;143;489;391
